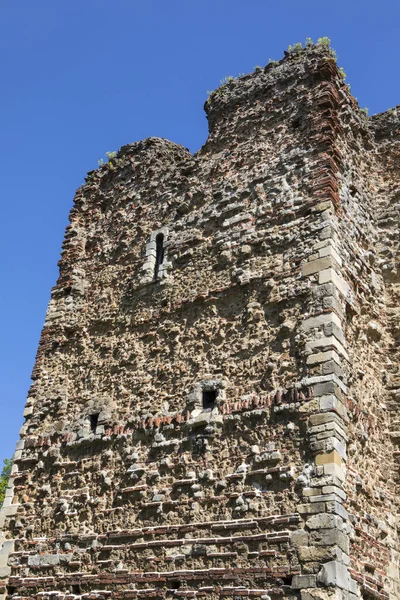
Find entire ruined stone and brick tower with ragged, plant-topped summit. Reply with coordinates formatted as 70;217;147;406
0;45;400;600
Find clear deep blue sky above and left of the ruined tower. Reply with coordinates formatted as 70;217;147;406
0;0;400;461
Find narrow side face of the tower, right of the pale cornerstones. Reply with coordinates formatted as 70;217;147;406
318;82;400;598
